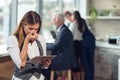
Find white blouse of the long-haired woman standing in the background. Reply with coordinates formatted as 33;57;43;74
69;21;83;41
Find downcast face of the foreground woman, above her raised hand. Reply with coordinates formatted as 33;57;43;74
23;23;40;35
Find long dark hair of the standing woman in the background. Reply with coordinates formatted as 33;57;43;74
73;11;83;32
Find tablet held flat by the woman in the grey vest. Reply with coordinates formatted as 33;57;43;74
27;55;56;63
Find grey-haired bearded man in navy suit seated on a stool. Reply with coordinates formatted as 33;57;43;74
47;13;77;79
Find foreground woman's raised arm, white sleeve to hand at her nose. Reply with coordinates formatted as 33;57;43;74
8;33;38;69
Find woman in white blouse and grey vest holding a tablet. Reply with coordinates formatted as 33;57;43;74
8;11;51;80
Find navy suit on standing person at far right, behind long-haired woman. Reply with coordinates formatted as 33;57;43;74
81;19;95;80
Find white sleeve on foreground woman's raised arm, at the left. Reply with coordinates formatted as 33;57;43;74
7;35;21;69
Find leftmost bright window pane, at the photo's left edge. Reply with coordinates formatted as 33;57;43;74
0;0;11;44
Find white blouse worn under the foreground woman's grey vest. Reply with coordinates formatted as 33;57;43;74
7;35;46;80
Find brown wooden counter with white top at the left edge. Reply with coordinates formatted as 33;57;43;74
0;44;14;80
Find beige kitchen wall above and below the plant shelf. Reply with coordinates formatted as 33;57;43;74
87;0;120;38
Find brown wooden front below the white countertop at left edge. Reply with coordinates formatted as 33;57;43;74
0;56;14;80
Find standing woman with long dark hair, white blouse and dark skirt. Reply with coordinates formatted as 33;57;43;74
69;11;84;80
